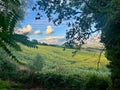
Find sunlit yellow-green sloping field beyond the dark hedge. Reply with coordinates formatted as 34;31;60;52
14;45;109;74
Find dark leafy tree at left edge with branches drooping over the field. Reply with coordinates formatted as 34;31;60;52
0;0;35;59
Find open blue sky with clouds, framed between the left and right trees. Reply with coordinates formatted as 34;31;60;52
16;1;68;44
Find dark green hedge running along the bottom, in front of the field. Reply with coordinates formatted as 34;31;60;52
25;73;110;90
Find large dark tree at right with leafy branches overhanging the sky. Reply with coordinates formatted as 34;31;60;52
33;0;120;90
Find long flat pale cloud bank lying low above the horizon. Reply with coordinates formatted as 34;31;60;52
39;36;65;44
